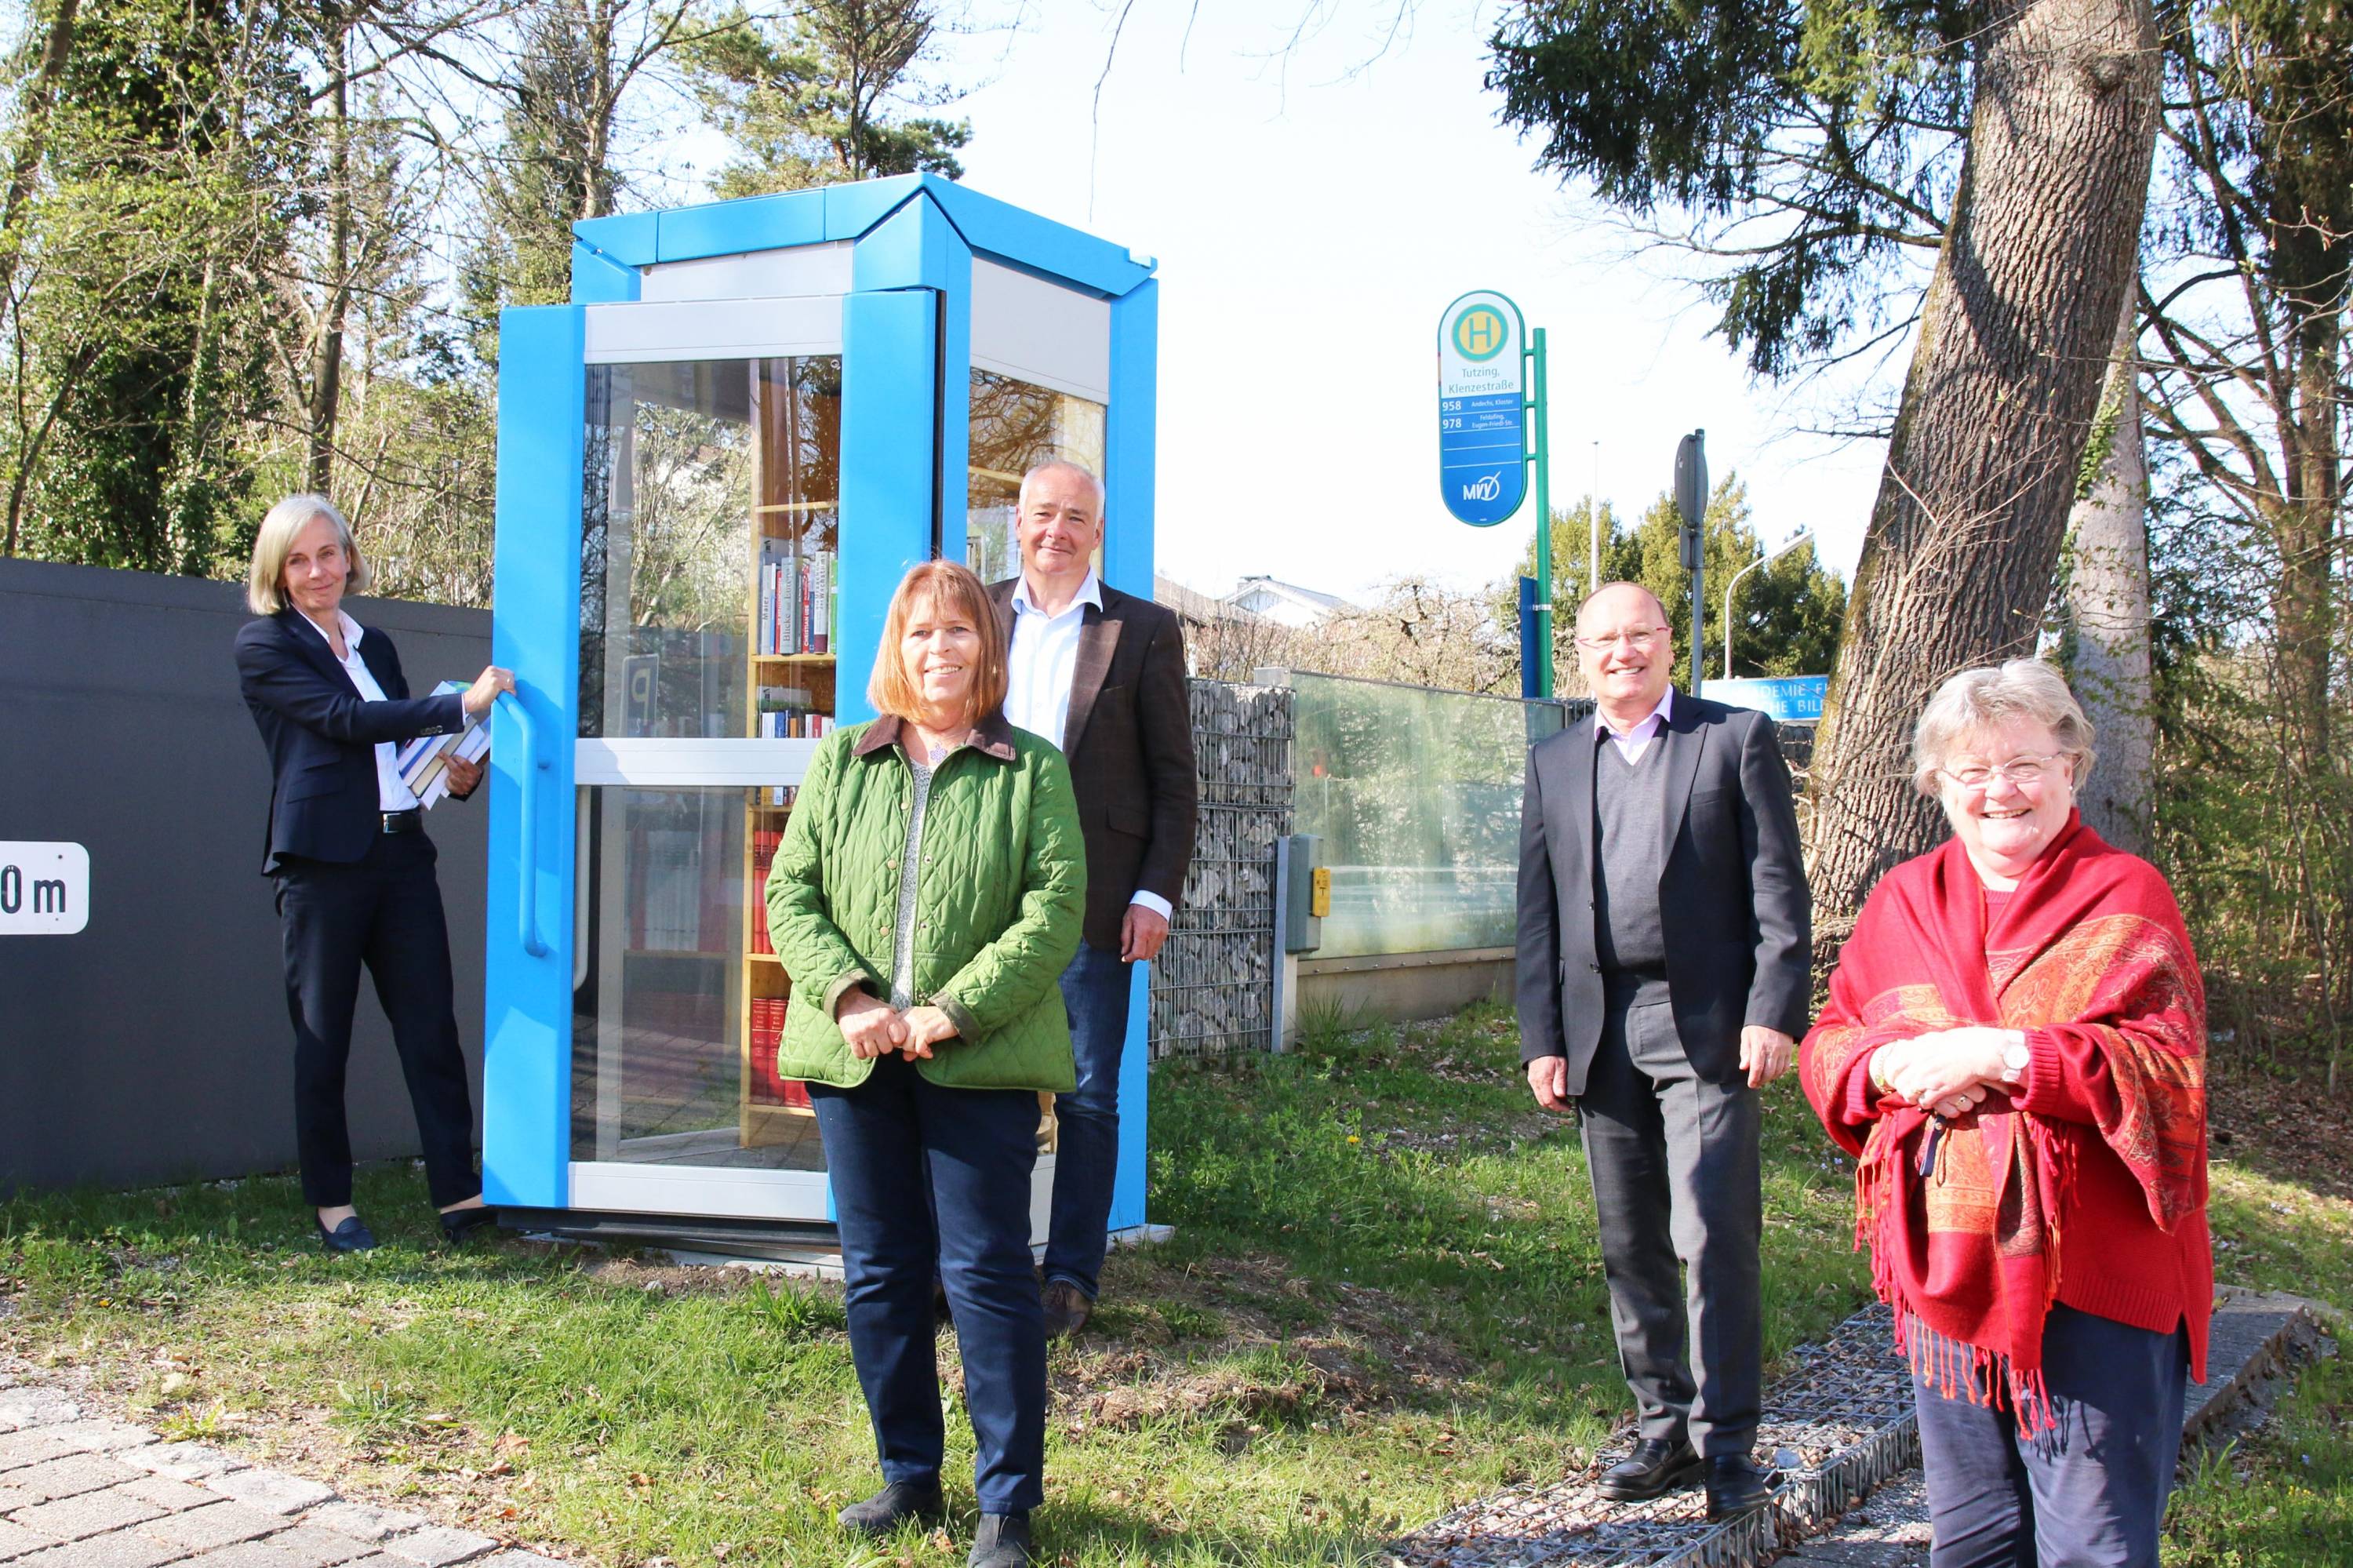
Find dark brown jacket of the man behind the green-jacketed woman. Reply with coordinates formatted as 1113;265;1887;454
988;577;1200;954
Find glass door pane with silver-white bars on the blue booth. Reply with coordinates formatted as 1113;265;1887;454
572;320;842;1220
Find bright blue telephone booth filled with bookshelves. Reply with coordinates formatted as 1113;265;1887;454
482;174;1158;1246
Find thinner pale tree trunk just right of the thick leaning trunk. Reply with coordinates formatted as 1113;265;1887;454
2066;289;2158;855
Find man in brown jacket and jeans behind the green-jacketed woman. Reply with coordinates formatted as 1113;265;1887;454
988;461;1200;1335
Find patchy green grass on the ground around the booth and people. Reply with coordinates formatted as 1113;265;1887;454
0;1008;2353;1568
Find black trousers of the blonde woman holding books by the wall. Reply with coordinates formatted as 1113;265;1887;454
273;834;482;1208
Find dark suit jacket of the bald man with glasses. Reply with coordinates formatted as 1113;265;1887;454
1515;692;1814;1095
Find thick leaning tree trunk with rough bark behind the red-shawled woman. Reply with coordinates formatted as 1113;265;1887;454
1807;0;2158;927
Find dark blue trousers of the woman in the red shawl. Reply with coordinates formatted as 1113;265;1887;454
1913;1304;2191;1568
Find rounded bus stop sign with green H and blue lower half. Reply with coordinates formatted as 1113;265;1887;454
1438;289;1527;527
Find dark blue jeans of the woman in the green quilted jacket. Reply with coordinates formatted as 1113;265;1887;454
809;1057;1045;1514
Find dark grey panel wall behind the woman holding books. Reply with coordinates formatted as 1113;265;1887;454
0;560;489;1189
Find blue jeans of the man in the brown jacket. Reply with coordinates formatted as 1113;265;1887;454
1045;942;1129;1302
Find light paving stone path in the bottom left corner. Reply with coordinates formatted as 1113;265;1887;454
0;1370;574;1568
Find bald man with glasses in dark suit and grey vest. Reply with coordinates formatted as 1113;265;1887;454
1515;581;1812;1519
